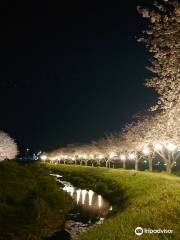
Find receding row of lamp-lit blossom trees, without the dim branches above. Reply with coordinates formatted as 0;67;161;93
41;108;180;172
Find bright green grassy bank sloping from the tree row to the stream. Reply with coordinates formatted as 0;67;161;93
46;165;180;240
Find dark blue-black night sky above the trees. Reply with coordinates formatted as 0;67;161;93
0;0;158;151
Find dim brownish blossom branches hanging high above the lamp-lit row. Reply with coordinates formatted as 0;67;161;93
138;0;180;110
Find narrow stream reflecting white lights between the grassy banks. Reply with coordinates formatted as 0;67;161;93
49;174;112;240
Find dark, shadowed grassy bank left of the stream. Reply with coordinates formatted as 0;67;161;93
0;161;70;240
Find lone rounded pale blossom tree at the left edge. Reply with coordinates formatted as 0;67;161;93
0;131;18;161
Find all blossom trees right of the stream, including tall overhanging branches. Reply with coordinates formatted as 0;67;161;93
41;0;180;172
